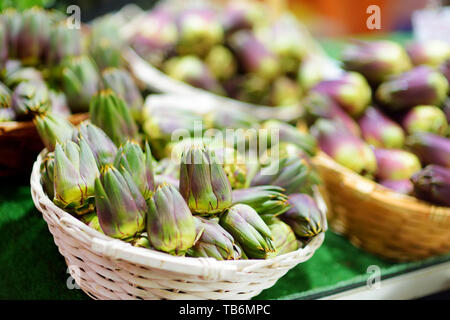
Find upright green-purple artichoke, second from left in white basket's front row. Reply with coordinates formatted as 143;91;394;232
95;165;147;239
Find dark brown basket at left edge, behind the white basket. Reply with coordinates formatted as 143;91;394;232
0;113;89;177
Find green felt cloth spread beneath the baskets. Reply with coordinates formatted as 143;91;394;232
0;34;450;299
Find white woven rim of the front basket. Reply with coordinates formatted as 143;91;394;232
30;149;327;279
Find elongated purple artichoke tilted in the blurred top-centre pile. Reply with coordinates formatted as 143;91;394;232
229;31;280;80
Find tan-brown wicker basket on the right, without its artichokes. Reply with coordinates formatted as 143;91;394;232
314;153;450;261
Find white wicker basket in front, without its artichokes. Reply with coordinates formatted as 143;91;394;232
30;150;326;300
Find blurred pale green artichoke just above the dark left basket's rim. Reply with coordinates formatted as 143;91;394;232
12;82;51;119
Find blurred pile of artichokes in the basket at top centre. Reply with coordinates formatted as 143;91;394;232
129;1;325;106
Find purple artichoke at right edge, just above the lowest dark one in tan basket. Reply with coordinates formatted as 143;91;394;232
406;132;450;168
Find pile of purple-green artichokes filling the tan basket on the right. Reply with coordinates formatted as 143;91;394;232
303;40;450;206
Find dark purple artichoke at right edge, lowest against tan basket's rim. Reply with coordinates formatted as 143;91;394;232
411;165;450;207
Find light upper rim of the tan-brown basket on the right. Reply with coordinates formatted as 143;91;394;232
313;151;450;217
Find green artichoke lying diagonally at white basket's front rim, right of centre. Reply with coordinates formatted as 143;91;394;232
219;204;276;259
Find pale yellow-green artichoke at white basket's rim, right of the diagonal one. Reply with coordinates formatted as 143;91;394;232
266;218;299;256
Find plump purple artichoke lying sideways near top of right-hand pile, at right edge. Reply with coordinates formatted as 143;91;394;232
376;66;448;111
